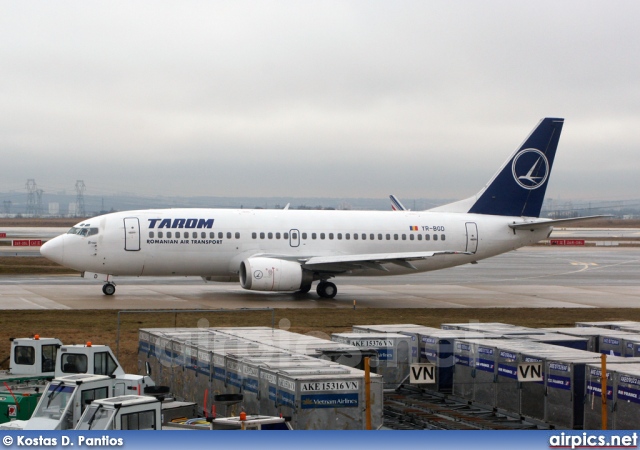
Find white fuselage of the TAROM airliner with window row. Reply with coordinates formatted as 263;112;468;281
43;209;552;281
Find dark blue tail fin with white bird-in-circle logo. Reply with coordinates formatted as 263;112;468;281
469;118;564;217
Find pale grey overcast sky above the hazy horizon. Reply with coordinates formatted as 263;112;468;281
0;0;640;204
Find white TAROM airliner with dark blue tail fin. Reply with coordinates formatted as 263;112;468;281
40;118;602;298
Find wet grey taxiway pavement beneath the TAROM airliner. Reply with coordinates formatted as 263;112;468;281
0;247;640;310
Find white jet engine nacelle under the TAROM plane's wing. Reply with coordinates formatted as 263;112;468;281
240;257;313;291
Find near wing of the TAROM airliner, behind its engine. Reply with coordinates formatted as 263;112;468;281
299;250;472;272
